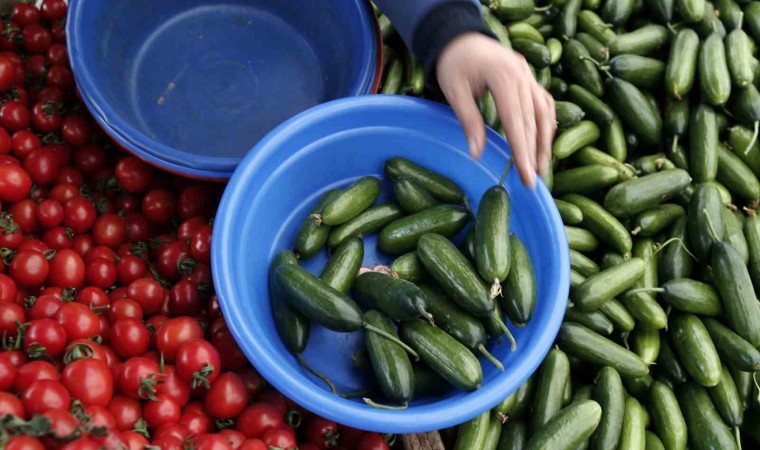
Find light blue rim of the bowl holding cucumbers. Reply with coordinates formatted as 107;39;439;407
211;95;570;433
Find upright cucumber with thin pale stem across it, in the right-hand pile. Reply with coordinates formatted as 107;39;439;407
687;183;724;261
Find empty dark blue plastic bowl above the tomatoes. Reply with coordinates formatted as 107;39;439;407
66;0;382;179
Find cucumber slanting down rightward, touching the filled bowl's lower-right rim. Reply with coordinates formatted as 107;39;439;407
557;322;649;378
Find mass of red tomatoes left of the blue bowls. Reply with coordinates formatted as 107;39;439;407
0;0;389;450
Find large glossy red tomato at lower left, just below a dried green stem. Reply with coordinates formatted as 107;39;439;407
61;358;113;406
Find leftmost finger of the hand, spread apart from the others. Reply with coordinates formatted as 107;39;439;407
441;80;486;158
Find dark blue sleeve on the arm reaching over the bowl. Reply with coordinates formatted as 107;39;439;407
375;0;493;86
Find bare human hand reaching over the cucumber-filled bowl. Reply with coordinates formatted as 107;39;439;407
436;33;557;187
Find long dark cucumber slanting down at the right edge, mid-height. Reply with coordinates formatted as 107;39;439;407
710;242;760;347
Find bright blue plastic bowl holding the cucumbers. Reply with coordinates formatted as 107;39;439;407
212;95;570;433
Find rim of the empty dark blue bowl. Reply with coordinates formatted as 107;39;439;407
66;0;383;181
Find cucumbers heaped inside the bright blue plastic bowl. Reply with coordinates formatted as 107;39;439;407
270;158;536;409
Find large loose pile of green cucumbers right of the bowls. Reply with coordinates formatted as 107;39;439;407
374;0;760;450
